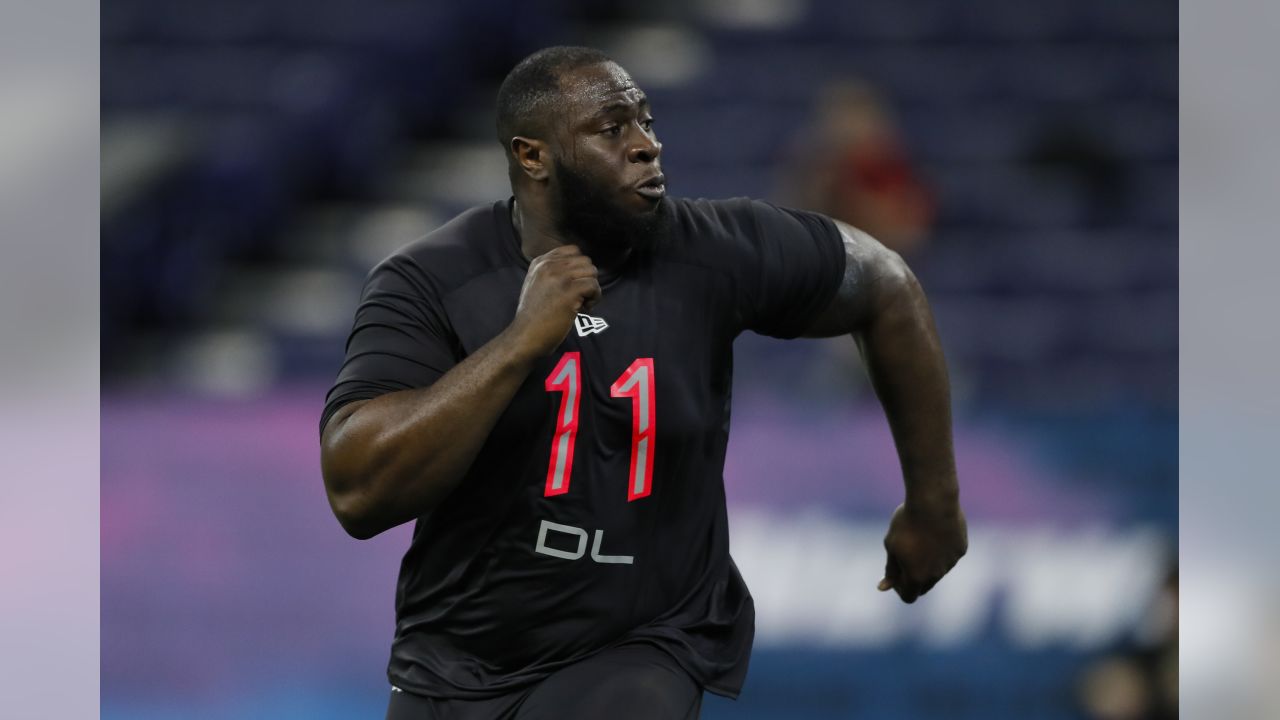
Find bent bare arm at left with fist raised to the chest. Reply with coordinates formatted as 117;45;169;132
320;246;600;539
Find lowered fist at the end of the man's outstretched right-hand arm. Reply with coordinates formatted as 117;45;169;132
879;491;969;602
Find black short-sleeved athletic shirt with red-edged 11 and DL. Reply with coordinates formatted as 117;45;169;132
320;199;845;698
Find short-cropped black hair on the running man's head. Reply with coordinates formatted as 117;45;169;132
498;45;613;156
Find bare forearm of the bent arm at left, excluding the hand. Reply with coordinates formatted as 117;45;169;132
321;329;536;538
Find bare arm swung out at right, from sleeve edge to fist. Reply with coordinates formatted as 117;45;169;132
804;220;969;602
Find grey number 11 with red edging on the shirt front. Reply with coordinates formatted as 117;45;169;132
544;352;655;502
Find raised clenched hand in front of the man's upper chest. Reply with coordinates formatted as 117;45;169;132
511;245;600;356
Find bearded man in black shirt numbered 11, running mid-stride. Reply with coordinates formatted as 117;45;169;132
321;47;966;719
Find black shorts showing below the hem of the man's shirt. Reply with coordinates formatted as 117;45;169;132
387;644;703;720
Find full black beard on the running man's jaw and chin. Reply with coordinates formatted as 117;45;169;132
556;160;669;265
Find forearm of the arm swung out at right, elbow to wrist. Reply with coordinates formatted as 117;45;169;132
855;260;959;506
